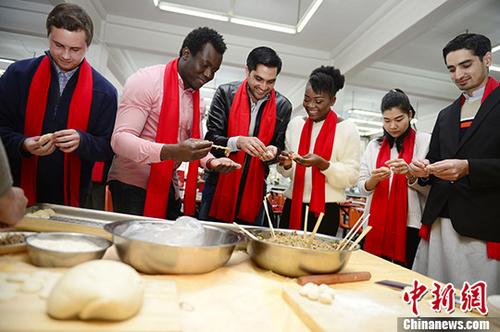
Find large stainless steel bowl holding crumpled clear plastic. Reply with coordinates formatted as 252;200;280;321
104;220;243;274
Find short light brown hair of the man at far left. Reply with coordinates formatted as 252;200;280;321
45;3;94;46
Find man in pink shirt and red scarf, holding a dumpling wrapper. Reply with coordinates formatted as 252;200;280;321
108;27;240;219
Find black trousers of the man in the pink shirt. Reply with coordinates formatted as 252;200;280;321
109;180;182;220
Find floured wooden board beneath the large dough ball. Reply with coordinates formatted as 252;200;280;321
0;255;181;332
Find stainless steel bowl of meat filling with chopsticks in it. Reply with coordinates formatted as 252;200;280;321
247;229;359;277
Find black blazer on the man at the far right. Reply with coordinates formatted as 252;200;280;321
422;87;500;242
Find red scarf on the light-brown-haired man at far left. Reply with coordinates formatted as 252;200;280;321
21;56;93;206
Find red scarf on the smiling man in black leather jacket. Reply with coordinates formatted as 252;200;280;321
210;80;276;223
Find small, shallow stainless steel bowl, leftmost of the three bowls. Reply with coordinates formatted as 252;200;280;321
26;232;112;267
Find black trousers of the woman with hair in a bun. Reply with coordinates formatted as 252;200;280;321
280;198;340;236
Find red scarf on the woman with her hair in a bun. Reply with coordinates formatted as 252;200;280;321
290;111;337;229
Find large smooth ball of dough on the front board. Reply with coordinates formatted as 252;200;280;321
47;260;144;320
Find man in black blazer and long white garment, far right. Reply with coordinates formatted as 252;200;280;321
411;33;500;294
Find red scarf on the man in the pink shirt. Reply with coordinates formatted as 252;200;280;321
144;58;200;218
